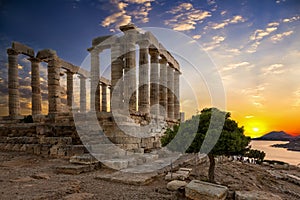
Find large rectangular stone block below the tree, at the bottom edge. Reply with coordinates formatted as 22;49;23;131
185;180;228;200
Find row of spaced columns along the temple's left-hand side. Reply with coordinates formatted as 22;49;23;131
7;48;108;119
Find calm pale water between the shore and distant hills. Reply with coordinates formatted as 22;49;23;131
250;140;300;165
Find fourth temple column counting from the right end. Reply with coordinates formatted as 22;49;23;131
149;49;159;116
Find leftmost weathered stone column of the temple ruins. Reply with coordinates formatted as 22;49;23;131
7;49;20;118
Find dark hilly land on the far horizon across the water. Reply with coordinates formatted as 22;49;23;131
252;131;300;151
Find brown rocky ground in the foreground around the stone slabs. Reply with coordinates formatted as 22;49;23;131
0;152;300;200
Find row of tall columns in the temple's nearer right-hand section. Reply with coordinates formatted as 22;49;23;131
90;37;180;120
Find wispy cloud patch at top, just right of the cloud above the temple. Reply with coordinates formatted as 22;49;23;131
165;3;211;31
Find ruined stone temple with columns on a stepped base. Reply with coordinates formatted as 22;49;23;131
0;24;181;168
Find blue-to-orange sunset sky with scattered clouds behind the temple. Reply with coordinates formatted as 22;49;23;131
0;0;300;137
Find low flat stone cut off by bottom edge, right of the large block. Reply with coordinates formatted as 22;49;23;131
235;191;281;200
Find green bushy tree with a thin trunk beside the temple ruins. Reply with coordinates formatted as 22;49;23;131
162;108;250;182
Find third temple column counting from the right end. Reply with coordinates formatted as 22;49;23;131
159;57;168;118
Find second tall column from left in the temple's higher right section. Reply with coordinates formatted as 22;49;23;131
110;39;124;110
